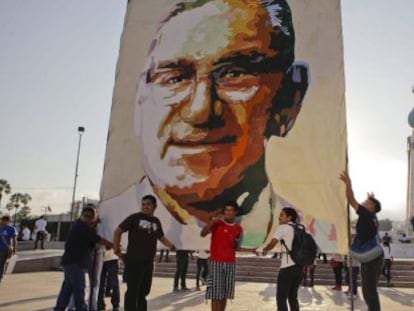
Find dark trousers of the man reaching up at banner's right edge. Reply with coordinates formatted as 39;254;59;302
361;255;384;311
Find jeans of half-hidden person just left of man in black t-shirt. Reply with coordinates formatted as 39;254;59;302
98;259;119;309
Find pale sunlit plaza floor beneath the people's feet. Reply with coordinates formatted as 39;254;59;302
0;272;414;311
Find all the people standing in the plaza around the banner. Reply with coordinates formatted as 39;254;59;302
0;172;402;311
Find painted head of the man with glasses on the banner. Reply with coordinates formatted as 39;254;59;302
136;0;307;222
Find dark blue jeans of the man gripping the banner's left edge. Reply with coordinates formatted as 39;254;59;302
54;264;88;311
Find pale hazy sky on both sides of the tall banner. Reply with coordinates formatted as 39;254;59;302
0;0;414;220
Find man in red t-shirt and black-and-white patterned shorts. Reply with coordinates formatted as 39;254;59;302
201;202;253;311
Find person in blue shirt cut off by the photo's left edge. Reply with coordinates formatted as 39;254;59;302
0;215;17;282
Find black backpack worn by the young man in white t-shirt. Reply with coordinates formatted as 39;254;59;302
281;224;318;266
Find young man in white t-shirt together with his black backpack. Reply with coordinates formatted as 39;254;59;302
262;207;317;311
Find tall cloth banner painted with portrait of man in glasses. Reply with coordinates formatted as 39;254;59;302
100;0;347;252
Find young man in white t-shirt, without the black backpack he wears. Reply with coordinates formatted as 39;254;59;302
263;207;303;311
